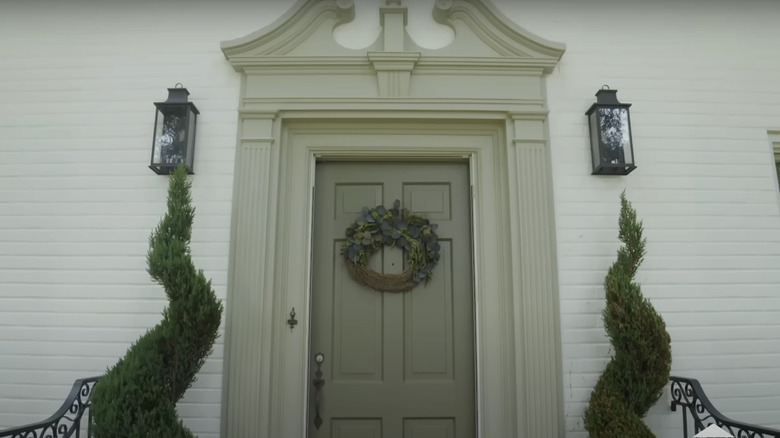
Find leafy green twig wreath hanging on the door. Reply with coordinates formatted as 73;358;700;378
341;200;441;292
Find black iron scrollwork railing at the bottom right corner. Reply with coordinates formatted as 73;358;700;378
669;376;780;438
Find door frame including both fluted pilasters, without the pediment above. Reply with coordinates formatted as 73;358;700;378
223;110;563;438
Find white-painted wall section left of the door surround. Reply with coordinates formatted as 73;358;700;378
0;1;285;438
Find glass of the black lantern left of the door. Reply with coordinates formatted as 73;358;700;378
152;107;187;167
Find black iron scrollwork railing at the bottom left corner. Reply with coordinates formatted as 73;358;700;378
0;377;99;438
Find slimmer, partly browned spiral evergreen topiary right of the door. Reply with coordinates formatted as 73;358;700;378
584;192;672;438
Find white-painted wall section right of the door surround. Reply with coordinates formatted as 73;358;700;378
506;1;780;438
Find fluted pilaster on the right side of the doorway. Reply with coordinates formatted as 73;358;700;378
510;115;563;438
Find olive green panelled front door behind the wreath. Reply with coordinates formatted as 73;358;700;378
308;162;476;438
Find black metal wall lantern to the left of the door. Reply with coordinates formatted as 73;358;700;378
149;84;200;175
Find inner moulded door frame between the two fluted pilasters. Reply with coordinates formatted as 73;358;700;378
271;120;517;437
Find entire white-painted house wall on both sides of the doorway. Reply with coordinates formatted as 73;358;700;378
0;0;780;438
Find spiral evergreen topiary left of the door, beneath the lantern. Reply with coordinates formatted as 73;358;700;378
92;166;222;438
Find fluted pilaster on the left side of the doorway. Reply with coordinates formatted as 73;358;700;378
223;113;274;438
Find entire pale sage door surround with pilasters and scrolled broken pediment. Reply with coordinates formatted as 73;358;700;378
222;0;564;438
